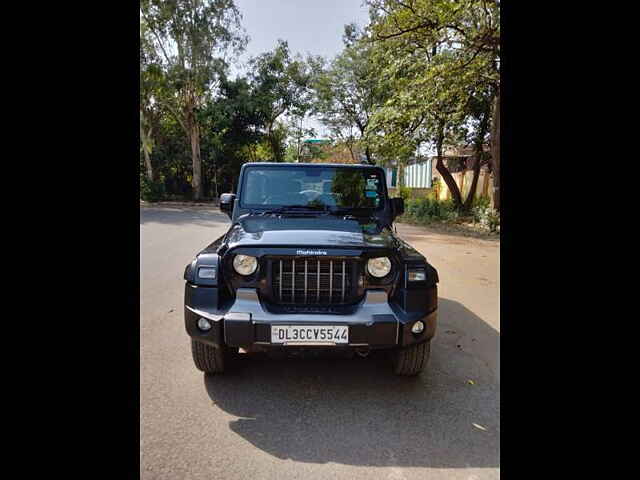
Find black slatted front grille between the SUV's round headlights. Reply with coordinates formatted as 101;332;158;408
271;258;356;305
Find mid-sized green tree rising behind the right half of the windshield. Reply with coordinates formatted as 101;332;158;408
313;24;383;164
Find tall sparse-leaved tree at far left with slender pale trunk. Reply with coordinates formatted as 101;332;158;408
140;0;247;199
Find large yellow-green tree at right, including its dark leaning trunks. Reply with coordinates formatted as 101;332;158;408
367;0;500;208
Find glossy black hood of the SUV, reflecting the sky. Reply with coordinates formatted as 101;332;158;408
227;216;395;248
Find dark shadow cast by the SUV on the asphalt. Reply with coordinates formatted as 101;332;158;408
204;298;500;468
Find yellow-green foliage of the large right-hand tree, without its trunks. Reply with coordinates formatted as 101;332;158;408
366;0;500;203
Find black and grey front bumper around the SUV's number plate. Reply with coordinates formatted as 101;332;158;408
185;285;437;348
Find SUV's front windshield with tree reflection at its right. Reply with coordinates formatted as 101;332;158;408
241;166;384;209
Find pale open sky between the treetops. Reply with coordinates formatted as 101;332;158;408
232;0;369;137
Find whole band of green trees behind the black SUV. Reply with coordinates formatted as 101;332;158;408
140;0;500;208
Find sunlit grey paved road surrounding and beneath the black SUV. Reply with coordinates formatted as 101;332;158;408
140;207;500;480
